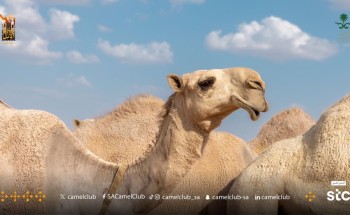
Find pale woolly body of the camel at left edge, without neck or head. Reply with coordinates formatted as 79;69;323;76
0;103;118;214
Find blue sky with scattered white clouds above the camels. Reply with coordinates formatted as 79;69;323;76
0;0;350;140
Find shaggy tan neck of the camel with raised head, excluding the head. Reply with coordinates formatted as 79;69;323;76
115;96;208;212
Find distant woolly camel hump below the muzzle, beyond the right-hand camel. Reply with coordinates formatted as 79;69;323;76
248;107;315;154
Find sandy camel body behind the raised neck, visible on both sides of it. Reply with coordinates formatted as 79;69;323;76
73;96;256;214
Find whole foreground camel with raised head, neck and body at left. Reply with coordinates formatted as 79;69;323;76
0;68;268;214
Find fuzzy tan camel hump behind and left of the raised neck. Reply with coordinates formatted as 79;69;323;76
73;95;164;164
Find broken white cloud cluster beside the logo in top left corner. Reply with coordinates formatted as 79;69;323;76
0;0;79;64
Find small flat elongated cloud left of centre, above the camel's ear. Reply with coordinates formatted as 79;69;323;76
97;39;173;63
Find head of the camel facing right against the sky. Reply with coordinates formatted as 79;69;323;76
168;68;269;132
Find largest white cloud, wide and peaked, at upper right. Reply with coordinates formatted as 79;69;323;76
206;16;337;60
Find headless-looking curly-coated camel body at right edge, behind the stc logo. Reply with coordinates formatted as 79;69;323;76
228;95;350;214
